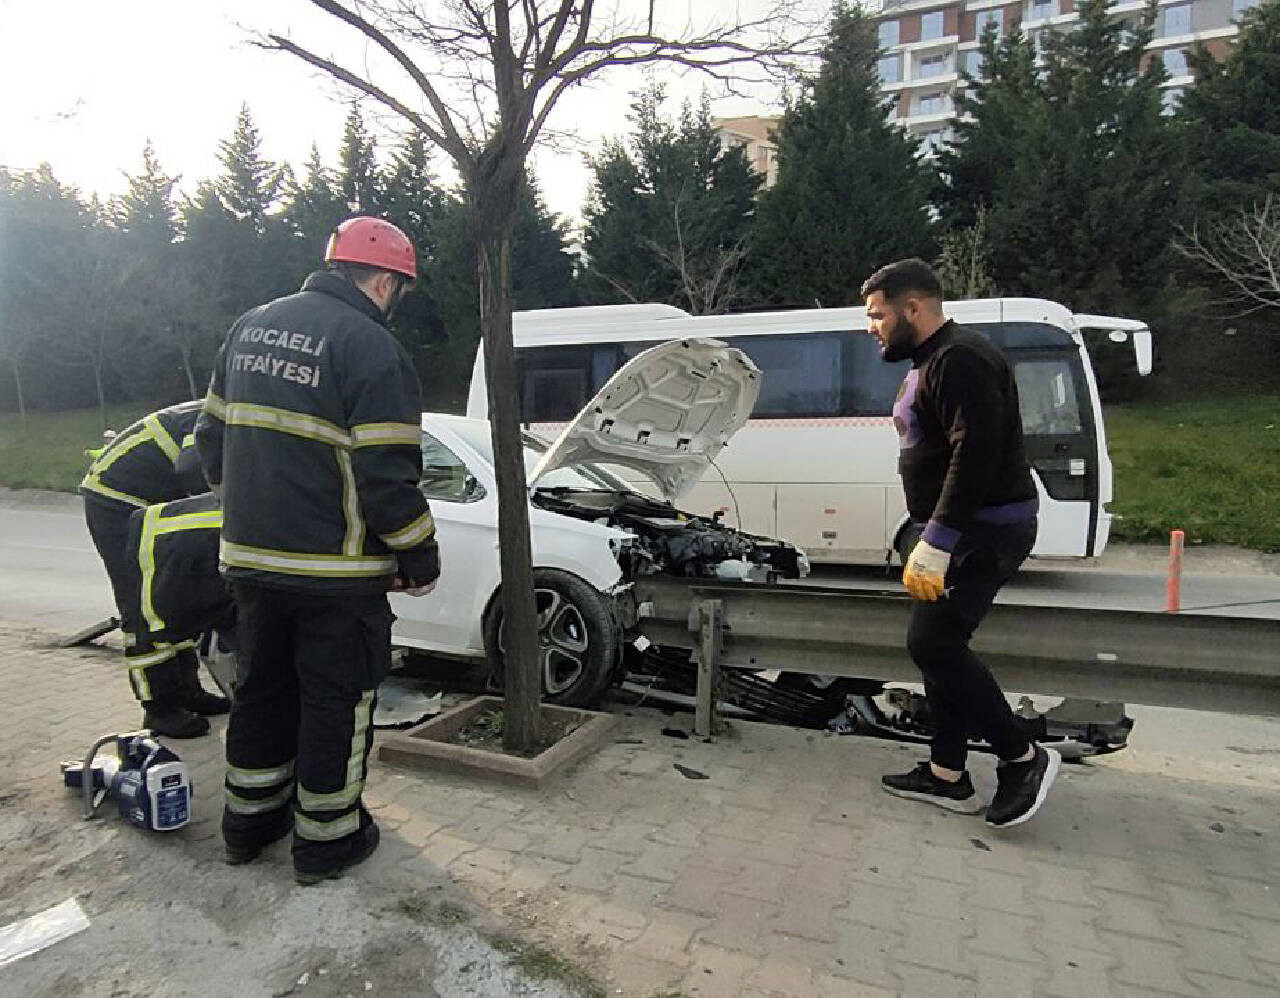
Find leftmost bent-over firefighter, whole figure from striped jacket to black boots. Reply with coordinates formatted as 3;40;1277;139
79;400;229;738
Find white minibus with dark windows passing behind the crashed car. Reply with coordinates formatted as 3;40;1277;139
467;298;1152;563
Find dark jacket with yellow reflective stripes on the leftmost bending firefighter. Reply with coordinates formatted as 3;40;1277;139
79;400;209;507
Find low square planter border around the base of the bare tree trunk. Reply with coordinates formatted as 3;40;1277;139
378;696;618;787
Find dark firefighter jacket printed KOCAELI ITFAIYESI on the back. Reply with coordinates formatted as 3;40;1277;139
196;271;439;591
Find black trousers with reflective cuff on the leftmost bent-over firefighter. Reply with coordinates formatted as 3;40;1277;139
84;496;186;704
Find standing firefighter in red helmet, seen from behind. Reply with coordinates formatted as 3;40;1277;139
196;216;439;884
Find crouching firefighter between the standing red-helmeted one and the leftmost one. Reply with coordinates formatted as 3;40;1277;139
124;493;236;701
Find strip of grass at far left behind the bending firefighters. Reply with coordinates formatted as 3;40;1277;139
0;403;152;493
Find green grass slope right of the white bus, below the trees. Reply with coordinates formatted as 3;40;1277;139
1106;395;1280;551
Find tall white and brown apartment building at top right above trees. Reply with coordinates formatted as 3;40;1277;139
874;0;1258;155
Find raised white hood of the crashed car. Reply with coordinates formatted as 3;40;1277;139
529;339;760;502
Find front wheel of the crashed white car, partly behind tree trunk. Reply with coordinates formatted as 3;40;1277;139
484;568;620;706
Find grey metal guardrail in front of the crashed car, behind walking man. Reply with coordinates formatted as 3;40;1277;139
635;576;1280;715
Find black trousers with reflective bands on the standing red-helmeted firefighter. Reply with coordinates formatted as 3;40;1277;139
223;580;393;871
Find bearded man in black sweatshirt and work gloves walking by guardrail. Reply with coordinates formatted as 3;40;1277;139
861;260;1061;828
